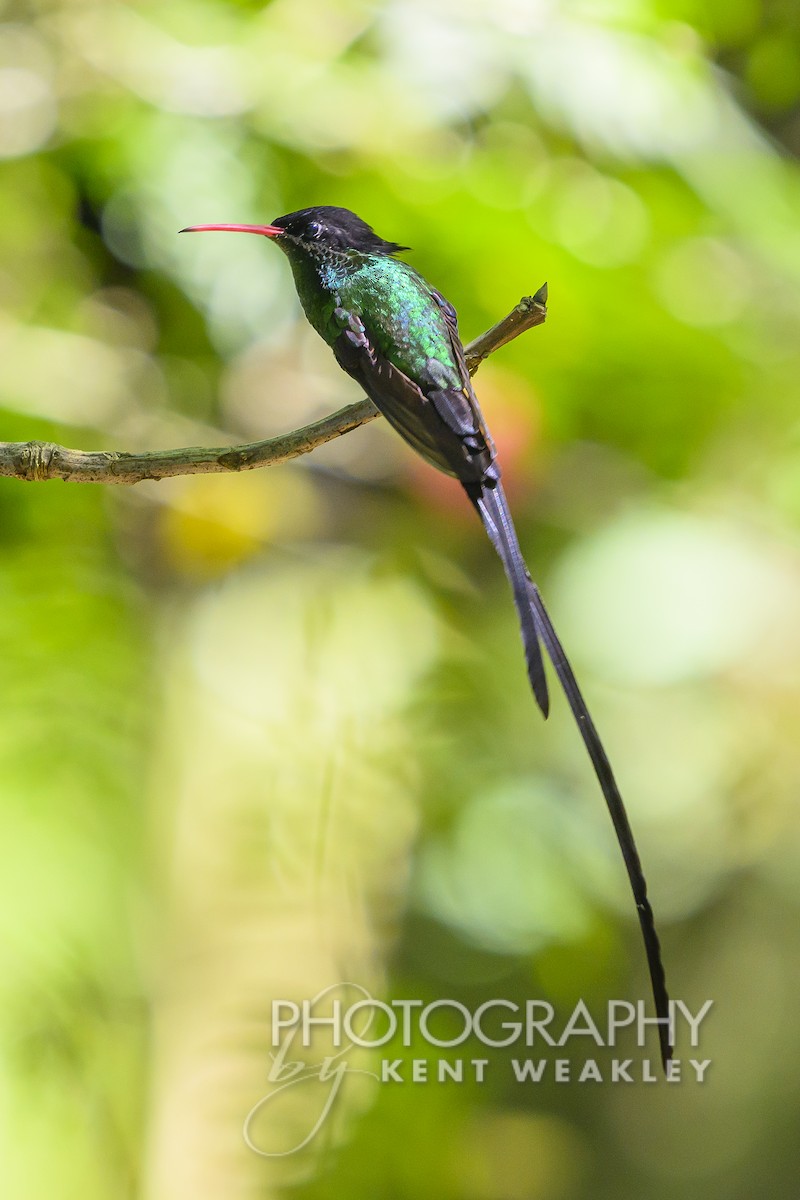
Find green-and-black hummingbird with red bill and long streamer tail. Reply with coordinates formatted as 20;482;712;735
181;205;672;1069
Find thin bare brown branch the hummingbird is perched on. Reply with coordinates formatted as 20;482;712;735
0;283;547;484
